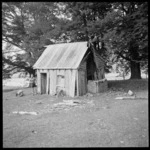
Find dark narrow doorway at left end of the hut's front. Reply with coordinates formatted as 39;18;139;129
41;73;47;94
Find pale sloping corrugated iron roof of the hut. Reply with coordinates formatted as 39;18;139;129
33;42;88;69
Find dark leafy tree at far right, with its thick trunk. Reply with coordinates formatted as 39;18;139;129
102;2;148;78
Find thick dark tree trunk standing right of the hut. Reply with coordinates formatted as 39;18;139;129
130;61;141;79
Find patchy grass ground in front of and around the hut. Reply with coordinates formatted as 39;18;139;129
3;79;149;147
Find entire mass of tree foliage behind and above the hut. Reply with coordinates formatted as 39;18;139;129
2;2;148;77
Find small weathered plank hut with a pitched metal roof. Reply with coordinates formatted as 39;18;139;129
33;42;105;97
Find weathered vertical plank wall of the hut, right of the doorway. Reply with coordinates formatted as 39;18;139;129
47;69;87;97
